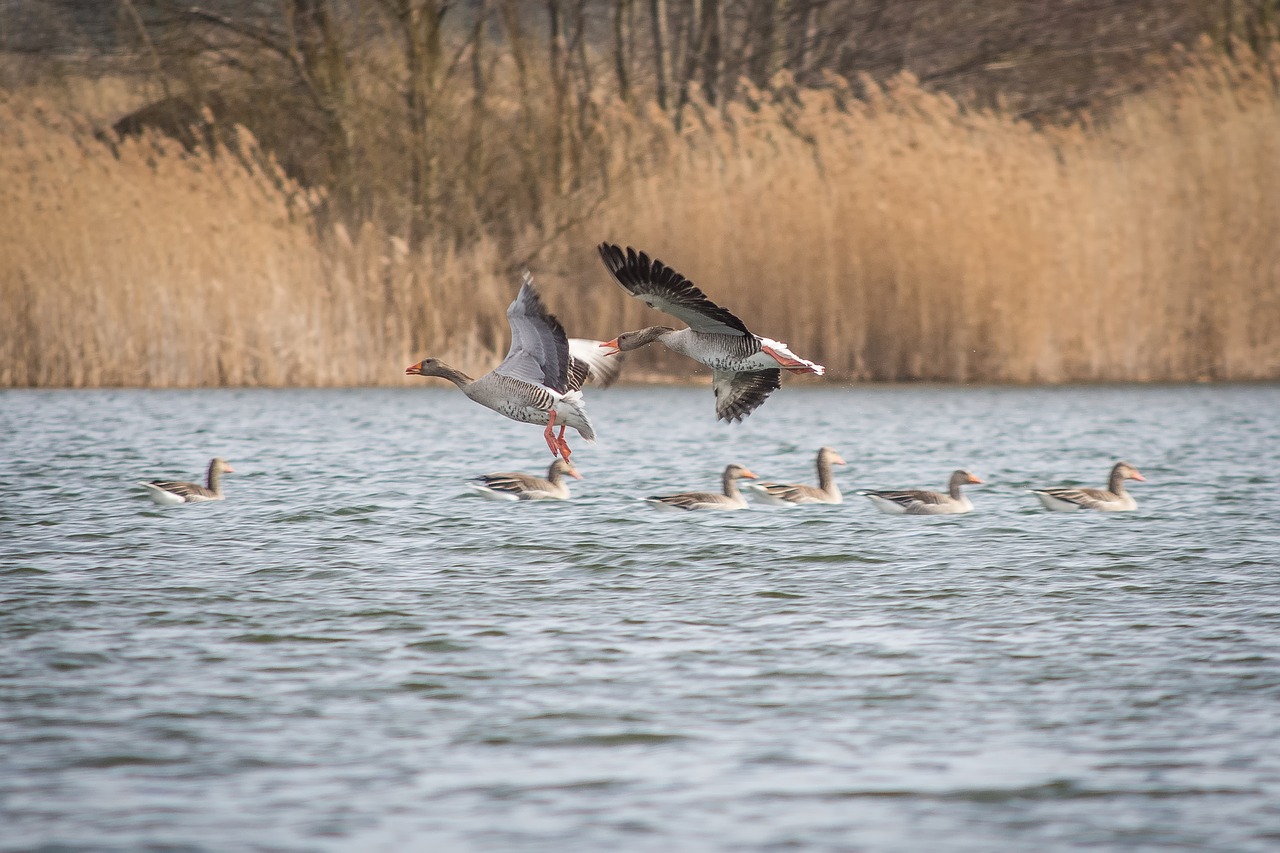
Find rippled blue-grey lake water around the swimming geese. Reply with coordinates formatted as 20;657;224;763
0;383;1280;853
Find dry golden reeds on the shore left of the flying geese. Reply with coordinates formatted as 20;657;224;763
0;101;507;387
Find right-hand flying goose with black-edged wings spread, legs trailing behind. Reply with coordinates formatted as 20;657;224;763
599;243;827;421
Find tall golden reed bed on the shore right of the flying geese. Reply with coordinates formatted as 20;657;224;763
582;63;1280;382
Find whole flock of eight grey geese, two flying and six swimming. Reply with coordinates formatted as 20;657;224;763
140;243;1144;515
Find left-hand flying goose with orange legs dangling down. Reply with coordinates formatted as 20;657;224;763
404;272;595;460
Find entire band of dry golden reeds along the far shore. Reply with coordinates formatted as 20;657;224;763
0;61;1280;387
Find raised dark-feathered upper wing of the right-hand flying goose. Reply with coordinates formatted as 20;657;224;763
599;243;751;336
